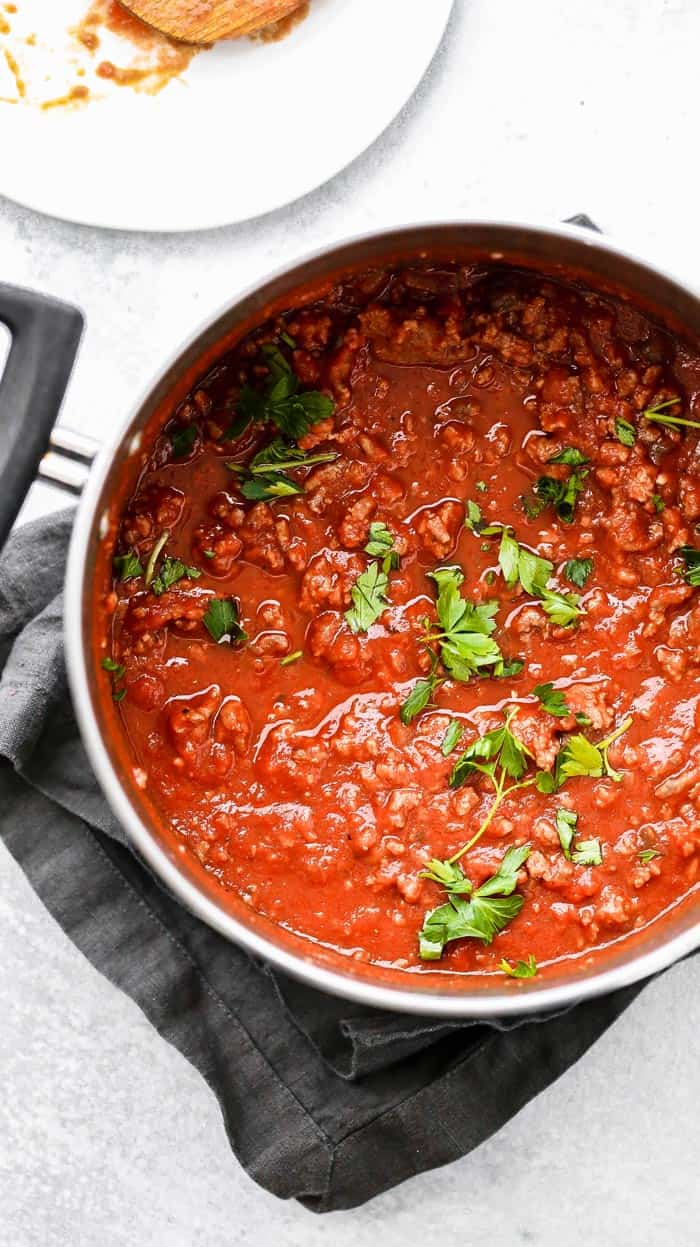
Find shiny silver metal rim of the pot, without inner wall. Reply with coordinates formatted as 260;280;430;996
65;218;700;1019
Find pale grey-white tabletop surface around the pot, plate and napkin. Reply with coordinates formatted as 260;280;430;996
0;0;700;1247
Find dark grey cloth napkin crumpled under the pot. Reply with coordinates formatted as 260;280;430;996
0;511;640;1212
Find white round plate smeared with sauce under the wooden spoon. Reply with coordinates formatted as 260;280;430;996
0;0;453;231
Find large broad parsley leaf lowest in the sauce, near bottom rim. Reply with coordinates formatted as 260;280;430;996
418;844;530;961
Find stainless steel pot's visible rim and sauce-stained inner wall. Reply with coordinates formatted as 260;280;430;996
6;222;700;1018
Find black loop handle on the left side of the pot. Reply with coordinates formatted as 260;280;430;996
0;282;82;546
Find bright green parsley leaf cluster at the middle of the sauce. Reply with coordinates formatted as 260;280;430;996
427;566;503;681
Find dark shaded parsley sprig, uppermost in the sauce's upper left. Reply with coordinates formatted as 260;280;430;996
236;342;334;441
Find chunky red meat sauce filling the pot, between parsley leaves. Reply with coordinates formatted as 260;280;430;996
105;264;700;973
